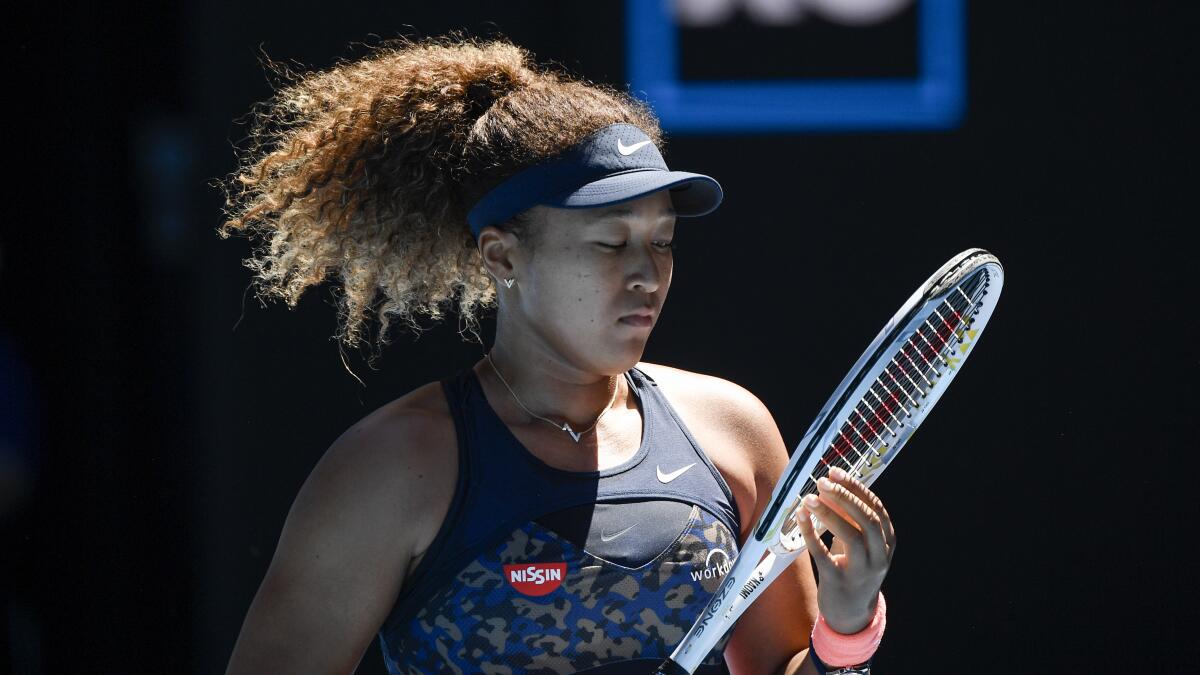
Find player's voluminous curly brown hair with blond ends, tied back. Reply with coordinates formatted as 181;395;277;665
217;34;662;362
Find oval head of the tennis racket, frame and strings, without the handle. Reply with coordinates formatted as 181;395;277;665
754;249;1004;552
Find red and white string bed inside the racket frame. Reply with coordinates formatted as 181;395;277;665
800;270;988;485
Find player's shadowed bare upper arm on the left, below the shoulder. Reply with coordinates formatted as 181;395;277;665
227;403;451;675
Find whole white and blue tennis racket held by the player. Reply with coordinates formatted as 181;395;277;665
655;249;1004;675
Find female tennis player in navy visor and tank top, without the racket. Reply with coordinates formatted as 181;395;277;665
221;36;895;674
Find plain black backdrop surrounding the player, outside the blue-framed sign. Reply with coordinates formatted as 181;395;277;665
0;0;1200;674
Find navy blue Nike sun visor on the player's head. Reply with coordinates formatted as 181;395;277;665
467;124;724;238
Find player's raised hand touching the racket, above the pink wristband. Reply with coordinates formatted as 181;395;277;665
796;468;896;634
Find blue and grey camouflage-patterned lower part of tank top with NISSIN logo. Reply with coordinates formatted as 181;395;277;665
382;507;737;675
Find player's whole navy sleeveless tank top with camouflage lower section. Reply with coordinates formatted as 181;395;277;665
379;368;739;675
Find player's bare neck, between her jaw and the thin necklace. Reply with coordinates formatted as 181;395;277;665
476;331;628;430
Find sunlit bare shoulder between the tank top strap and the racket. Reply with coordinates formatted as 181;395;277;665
637;363;787;533
